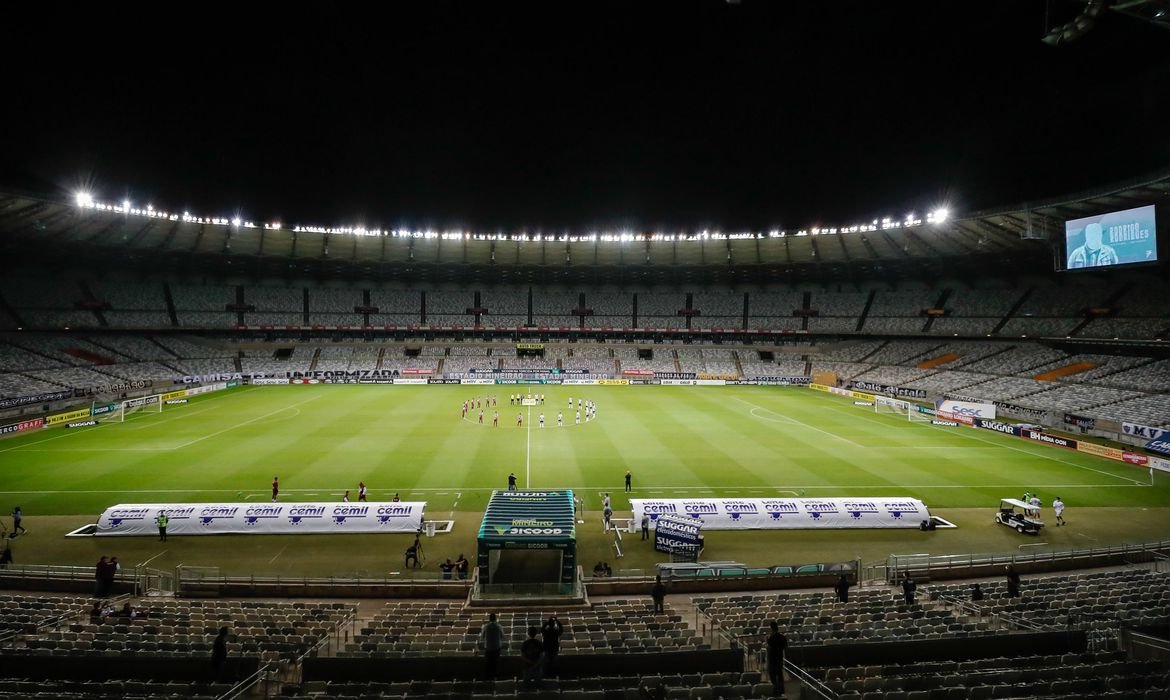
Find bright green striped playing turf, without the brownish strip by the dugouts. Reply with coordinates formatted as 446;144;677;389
0;385;1168;515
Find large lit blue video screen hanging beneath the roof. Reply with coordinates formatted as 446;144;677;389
1065;205;1158;269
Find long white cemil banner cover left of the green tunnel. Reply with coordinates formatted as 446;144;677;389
95;501;426;537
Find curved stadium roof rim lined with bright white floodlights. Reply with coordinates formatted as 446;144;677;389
0;171;1170;282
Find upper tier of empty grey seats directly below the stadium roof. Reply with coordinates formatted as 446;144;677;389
0;270;1170;341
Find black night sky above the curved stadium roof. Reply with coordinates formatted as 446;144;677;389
0;0;1170;231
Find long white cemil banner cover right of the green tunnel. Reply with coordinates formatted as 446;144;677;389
629;497;930;530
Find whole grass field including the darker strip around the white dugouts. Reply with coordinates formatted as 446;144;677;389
0;385;1170;575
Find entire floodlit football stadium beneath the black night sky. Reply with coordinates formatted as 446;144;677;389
0;0;1170;700
